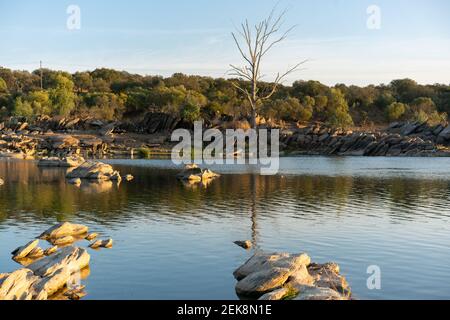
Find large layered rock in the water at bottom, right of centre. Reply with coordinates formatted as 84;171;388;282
233;253;351;300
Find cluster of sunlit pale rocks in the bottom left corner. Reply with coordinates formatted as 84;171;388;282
0;223;113;300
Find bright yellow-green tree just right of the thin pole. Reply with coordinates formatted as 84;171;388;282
50;74;75;116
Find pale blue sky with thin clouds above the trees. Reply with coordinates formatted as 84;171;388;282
0;0;450;85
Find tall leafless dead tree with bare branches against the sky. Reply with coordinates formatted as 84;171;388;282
230;10;306;129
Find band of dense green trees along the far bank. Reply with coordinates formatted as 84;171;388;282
0;68;450;127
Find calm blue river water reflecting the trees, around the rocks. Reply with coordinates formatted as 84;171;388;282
0;157;450;299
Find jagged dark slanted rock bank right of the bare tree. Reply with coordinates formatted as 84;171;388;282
280;122;450;157
